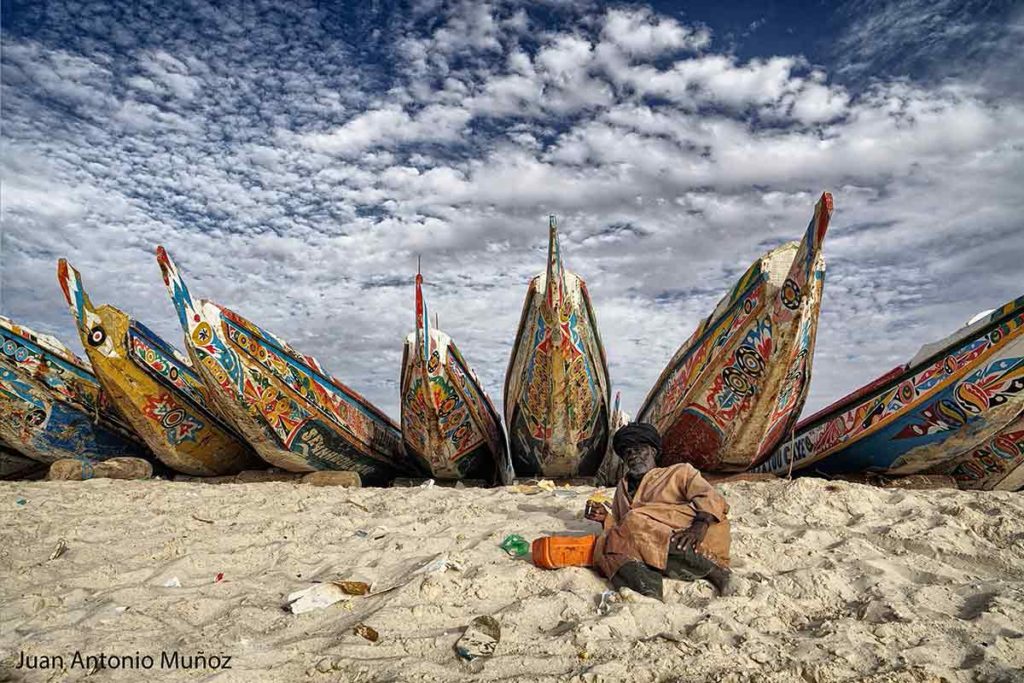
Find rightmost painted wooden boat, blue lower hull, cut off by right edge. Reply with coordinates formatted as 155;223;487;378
759;297;1024;488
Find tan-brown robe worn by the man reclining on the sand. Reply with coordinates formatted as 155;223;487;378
594;463;730;579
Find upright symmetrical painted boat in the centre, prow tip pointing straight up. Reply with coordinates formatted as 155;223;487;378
505;216;611;477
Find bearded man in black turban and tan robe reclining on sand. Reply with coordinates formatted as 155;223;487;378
591;423;729;600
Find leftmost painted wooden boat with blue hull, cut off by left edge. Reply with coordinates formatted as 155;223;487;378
0;316;151;464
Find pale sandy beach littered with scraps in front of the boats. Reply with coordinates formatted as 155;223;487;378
0;479;1024;681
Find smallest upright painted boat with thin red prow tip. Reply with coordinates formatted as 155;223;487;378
401;273;513;484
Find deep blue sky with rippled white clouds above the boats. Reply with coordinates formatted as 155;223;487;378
0;0;1024;420
